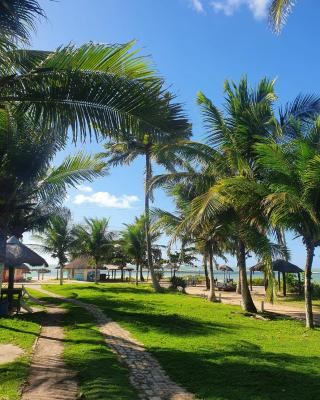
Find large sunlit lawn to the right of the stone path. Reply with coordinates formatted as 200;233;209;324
46;284;320;400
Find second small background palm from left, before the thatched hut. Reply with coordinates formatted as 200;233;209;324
72;218;114;284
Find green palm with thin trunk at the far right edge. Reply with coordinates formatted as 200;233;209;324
257;117;320;328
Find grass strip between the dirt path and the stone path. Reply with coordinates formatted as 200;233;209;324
28;289;137;400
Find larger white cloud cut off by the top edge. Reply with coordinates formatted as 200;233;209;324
211;0;270;19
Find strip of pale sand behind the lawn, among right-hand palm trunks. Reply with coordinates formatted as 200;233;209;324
186;286;320;324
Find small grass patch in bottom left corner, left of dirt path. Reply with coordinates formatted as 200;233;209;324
0;313;41;400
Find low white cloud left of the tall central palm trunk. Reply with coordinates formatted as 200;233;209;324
73;192;139;208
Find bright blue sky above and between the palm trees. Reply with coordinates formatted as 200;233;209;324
26;0;320;266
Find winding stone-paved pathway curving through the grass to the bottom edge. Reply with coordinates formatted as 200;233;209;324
33;287;194;400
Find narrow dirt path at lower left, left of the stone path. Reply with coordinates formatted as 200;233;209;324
21;306;77;400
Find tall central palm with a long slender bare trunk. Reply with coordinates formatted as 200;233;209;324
104;133;190;292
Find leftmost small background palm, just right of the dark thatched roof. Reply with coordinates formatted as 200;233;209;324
35;209;74;285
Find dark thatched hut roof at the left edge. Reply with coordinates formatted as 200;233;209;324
5;236;48;267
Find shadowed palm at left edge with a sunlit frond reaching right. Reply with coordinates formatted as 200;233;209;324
0;108;105;292
